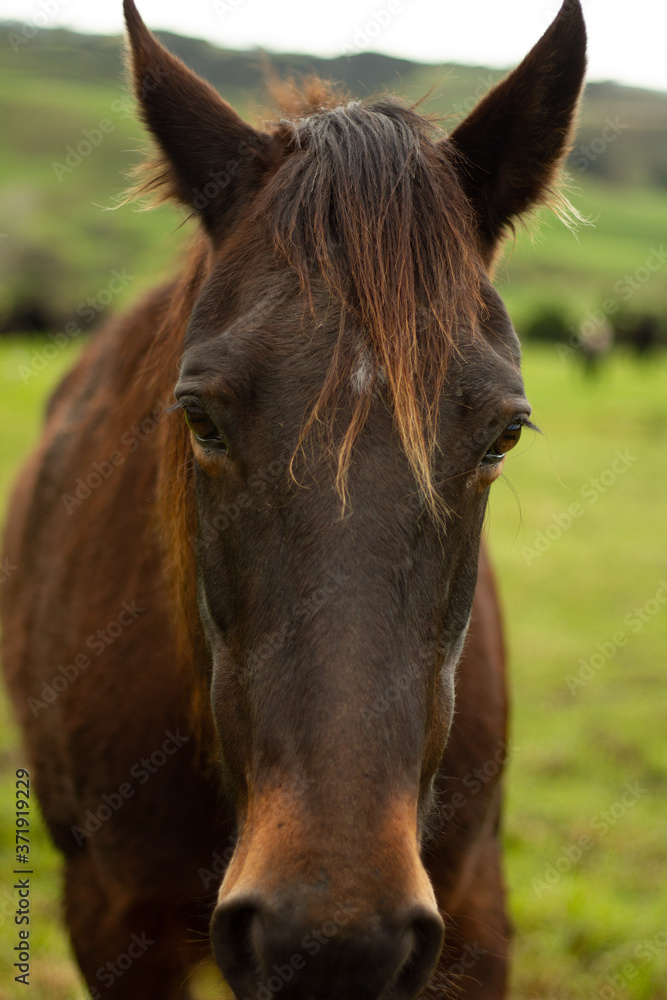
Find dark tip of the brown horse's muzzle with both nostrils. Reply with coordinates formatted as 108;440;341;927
211;892;444;1000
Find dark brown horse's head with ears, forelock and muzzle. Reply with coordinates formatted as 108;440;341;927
125;0;585;1000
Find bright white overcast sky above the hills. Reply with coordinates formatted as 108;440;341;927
0;0;667;91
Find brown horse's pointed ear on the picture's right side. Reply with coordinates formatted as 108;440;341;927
451;0;586;261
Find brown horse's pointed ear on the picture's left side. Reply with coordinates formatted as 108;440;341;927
123;0;276;238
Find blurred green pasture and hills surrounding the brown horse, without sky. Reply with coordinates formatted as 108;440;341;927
0;19;667;1000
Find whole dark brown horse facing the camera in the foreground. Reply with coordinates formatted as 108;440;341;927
2;0;586;1000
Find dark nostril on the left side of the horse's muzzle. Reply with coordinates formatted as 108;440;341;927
211;899;261;995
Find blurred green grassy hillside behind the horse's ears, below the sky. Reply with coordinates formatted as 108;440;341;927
0;25;667;330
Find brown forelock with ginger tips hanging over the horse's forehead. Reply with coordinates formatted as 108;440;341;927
257;98;482;511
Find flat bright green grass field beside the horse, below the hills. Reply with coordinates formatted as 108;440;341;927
0;340;667;1000
